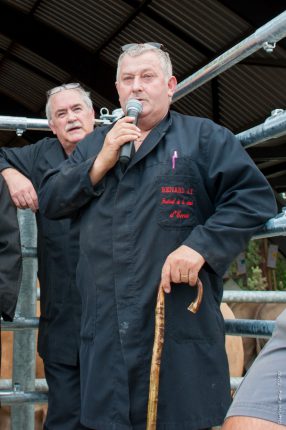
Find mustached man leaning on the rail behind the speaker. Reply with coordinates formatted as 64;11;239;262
0;83;94;430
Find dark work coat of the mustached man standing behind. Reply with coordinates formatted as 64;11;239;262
0;138;81;365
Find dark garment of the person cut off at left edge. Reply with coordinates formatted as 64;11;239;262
0;175;22;321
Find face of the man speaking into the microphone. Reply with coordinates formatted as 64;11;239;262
116;51;177;128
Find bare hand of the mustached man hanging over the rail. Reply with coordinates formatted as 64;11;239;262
1;168;39;212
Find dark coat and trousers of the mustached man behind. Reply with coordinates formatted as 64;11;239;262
0;137;83;430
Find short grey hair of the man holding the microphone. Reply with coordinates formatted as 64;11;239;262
116;43;173;81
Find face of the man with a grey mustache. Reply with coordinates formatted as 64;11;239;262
49;89;94;154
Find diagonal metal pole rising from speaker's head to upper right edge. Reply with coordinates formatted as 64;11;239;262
173;12;286;102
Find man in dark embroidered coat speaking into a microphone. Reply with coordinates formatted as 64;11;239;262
39;43;276;430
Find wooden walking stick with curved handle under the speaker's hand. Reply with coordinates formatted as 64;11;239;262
146;278;203;430
